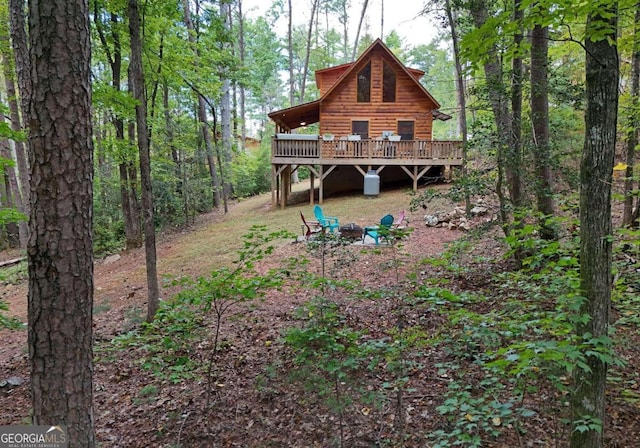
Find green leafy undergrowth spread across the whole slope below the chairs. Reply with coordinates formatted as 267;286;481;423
100;212;640;448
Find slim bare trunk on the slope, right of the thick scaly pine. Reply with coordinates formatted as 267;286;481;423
128;0;160;322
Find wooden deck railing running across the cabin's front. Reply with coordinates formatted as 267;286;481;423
271;137;462;161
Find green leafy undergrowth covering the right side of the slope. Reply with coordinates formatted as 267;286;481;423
283;216;638;447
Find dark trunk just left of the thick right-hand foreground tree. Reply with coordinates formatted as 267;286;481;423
531;21;556;240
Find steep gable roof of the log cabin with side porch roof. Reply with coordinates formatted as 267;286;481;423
268;38;451;130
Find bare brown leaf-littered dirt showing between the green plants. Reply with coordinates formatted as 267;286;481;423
0;193;640;448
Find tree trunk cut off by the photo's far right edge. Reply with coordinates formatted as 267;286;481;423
622;6;640;226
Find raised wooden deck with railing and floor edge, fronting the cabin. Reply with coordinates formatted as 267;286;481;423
271;137;462;166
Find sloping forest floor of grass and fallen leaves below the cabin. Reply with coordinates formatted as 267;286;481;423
0;183;640;448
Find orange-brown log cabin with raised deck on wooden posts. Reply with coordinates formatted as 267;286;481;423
268;39;462;208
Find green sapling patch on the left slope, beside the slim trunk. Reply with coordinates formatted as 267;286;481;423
97;226;291;383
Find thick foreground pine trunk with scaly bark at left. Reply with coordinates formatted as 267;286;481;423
27;0;95;448
